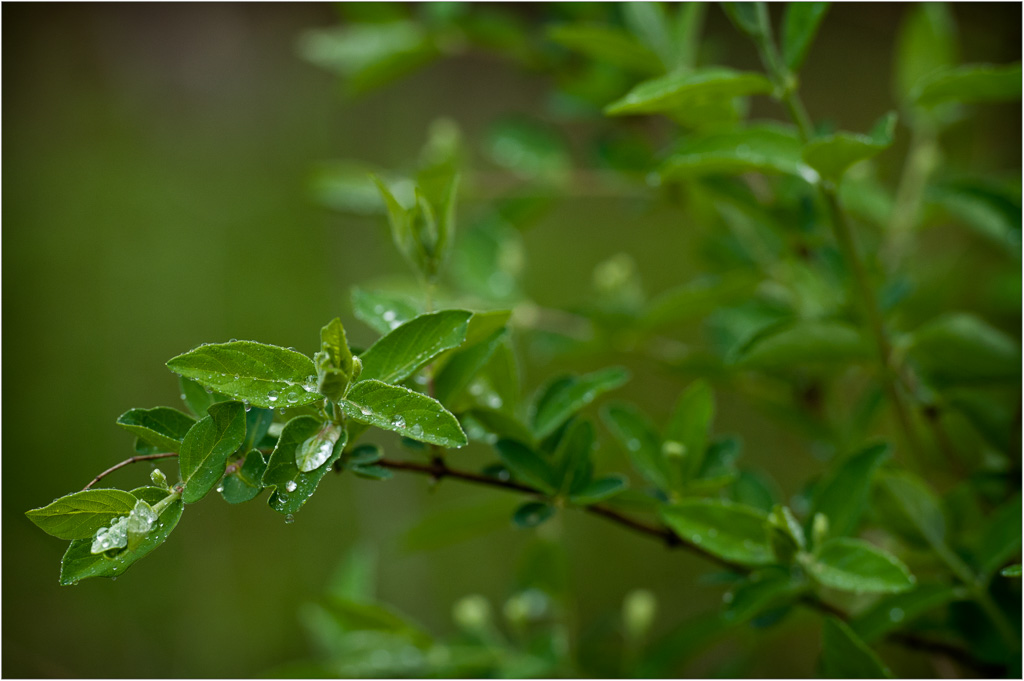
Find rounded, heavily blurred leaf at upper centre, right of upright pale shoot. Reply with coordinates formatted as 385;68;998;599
483;118;572;182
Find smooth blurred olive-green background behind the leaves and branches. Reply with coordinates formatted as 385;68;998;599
2;3;1021;677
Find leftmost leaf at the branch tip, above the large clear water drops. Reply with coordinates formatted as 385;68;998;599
26;490;135;539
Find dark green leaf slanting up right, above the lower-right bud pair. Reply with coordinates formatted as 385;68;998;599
807;442;891;537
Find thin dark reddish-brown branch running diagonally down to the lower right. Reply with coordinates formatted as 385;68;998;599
376;459;1005;676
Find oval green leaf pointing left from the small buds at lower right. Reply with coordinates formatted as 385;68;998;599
662;499;774;565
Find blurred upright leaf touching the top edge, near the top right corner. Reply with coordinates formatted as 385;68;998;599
893;2;957;100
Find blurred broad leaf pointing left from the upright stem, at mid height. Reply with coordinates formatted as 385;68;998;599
734;320;874;369
